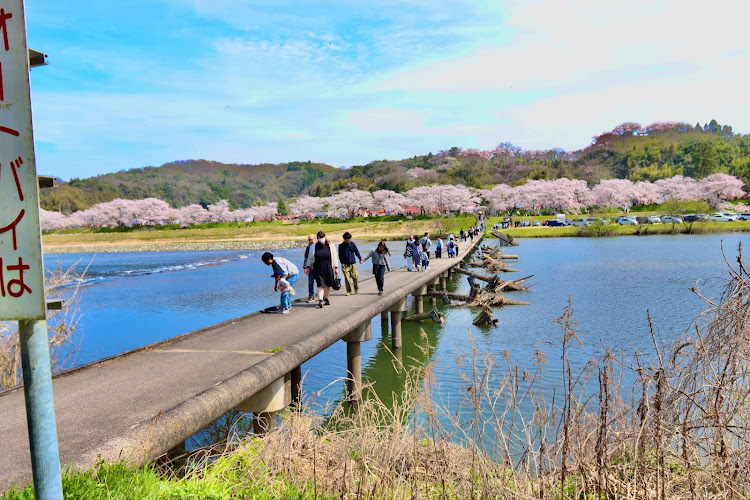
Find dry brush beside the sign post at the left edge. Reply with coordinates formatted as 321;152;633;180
0;267;80;390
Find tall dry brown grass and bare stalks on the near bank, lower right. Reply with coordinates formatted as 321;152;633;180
169;245;750;499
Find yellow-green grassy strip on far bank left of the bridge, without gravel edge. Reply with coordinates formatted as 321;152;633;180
42;216;476;248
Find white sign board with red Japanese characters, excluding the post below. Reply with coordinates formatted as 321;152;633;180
0;0;45;320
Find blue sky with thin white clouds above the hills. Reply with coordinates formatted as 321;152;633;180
26;0;750;179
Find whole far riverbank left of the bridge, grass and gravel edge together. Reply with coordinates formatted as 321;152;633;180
42;216;476;253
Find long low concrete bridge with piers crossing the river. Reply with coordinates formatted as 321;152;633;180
0;238;481;492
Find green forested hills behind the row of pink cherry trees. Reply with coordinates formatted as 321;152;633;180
41;120;750;213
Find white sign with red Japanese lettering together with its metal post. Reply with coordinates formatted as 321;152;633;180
0;0;62;500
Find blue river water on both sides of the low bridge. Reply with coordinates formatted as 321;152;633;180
45;233;748;446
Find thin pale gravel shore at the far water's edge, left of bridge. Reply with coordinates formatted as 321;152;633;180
43;241;307;254
